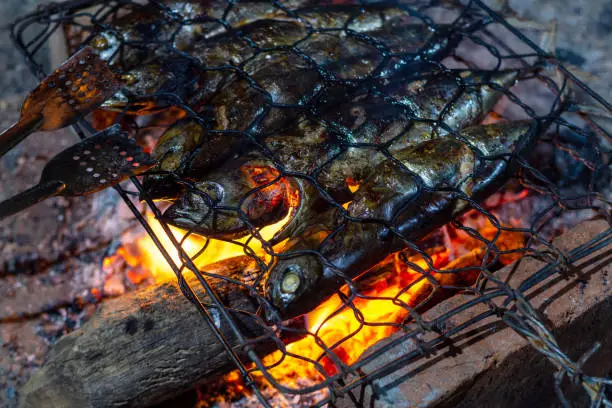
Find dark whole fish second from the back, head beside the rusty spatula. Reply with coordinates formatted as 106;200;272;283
104;11;478;115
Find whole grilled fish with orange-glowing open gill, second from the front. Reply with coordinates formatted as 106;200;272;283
155;70;520;242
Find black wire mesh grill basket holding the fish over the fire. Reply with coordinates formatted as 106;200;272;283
8;0;612;406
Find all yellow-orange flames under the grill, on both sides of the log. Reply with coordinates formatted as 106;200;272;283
105;188;525;406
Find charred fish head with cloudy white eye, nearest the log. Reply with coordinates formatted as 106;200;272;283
266;254;324;321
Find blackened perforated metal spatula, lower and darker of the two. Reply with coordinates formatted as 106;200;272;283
0;125;155;220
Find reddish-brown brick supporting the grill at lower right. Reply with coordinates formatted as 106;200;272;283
338;220;612;408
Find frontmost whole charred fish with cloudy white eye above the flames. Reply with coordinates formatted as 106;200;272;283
267;121;539;319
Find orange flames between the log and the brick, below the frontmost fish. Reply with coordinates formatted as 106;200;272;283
234;217;525;387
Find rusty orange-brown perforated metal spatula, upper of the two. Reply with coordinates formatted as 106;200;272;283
0;47;123;157
